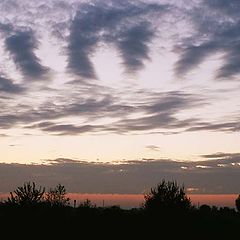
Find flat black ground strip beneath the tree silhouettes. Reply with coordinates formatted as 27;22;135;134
0;204;240;239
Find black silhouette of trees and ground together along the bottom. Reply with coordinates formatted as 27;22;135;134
0;180;240;239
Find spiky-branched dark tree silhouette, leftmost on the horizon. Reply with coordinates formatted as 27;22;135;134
7;182;45;206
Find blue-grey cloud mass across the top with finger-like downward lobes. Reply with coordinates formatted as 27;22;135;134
0;0;240;80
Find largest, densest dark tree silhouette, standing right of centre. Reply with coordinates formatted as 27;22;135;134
143;180;191;212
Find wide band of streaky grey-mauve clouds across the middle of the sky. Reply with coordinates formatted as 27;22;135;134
0;85;237;136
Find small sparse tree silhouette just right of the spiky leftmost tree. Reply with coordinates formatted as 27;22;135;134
45;184;70;207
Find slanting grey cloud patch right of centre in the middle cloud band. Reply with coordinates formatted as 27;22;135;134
111;92;204;132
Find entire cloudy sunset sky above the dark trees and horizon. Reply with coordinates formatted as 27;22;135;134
0;0;240;201
